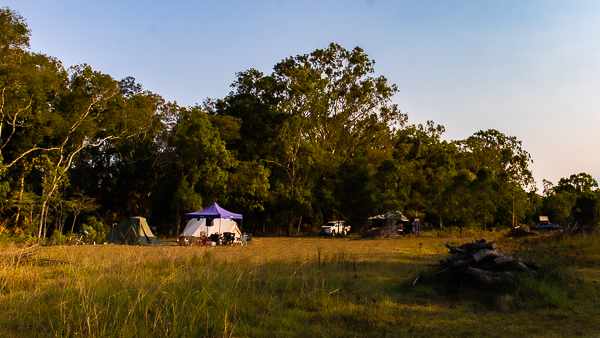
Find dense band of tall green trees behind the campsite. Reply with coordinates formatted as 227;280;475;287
0;8;600;238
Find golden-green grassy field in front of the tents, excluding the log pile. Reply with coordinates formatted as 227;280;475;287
0;232;600;337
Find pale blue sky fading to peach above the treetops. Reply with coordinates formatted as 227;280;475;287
0;0;600;185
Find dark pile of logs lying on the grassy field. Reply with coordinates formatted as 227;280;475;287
438;239;536;287
